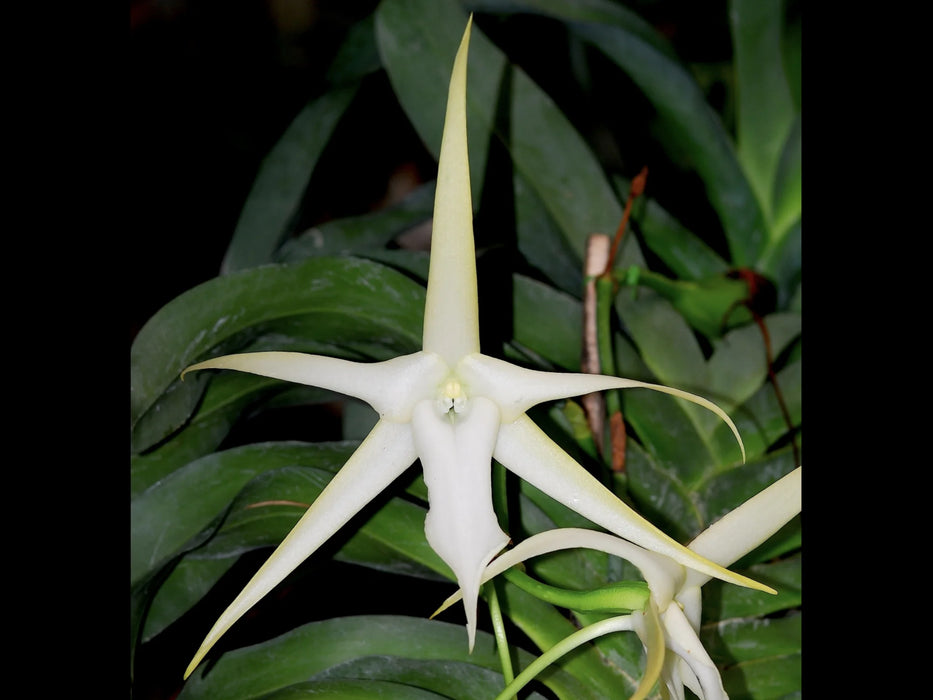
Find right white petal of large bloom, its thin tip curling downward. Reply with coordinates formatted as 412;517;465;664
457;353;745;459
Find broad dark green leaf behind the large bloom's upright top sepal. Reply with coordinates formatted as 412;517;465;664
377;0;641;294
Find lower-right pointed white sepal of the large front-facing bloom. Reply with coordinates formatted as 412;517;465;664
493;416;775;593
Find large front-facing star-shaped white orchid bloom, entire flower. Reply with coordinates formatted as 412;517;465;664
183;17;771;677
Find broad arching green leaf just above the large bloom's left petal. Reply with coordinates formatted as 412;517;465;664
130;258;424;452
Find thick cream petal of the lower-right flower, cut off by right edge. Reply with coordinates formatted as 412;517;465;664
688;467;803;586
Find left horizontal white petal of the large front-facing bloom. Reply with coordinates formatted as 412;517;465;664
182;352;449;422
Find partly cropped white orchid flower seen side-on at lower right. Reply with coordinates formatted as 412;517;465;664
434;467;802;700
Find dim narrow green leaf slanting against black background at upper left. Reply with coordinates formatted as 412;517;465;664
221;85;356;274
